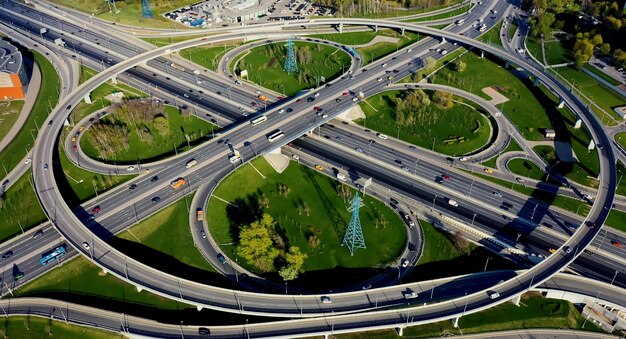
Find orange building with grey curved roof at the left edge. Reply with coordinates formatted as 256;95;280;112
0;40;28;100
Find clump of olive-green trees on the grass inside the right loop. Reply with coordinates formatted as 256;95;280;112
395;89;453;127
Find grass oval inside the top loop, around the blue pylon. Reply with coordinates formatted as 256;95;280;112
234;41;350;96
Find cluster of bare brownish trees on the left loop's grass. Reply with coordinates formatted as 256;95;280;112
87;99;173;159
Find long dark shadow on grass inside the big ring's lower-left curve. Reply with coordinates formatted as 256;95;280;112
107;237;235;288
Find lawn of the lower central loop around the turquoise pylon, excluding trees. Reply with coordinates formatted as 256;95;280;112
207;158;406;290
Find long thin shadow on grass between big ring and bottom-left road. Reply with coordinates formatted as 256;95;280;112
15;290;277;325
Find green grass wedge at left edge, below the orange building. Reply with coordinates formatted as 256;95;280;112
0;170;46;241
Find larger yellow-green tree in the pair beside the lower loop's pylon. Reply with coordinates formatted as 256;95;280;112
237;214;279;272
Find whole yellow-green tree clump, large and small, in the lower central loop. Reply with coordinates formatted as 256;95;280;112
237;213;307;281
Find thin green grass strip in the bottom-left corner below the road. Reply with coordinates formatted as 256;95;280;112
0;316;124;339
